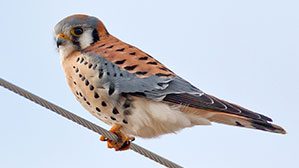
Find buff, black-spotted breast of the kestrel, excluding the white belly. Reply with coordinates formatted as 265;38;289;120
63;53;130;125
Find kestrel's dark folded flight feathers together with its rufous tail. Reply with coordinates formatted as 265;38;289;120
163;94;286;134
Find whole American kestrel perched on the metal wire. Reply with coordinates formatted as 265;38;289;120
55;15;286;150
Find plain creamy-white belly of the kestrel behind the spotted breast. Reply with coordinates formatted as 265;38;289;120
124;98;210;138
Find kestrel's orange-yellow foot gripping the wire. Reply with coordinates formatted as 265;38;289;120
100;124;135;151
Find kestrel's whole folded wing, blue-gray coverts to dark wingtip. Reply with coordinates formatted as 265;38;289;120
89;53;272;121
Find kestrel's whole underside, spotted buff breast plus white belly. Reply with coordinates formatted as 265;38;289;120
63;54;204;138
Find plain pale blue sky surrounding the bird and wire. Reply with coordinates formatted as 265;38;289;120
0;0;299;168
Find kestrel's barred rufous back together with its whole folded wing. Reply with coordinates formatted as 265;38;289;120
83;39;278;126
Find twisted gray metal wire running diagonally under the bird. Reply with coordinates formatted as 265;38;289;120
0;78;182;168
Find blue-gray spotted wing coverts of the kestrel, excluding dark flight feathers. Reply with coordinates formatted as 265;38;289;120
89;53;203;100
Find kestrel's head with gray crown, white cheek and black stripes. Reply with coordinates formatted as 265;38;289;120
54;14;109;58
